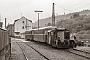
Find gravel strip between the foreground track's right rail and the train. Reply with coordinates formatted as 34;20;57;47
25;40;88;60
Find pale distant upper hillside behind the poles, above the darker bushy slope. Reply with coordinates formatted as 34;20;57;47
33;10;90;27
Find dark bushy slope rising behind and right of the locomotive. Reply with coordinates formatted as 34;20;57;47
56;15;90;39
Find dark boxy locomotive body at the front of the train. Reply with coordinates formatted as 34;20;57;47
51;28;70;48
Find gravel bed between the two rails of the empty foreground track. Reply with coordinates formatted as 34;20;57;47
19;42;46;60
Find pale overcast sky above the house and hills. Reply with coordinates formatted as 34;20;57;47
0;0;90;23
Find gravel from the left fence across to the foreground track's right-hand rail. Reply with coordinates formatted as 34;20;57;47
11;39;46;60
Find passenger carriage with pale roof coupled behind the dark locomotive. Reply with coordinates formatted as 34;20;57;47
25;26;56;42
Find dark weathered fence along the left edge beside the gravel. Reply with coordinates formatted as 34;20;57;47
0;28;11;60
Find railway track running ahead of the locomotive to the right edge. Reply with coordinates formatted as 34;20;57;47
65;49;90;59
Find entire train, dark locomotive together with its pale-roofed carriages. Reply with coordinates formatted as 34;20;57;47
25;26;77;48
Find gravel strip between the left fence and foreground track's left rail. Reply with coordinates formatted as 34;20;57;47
11;42;25;60
